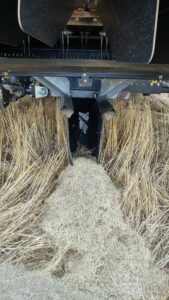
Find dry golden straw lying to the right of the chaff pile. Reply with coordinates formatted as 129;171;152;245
100;96;169;267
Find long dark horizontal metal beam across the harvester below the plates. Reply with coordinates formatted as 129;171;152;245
0;58;169;80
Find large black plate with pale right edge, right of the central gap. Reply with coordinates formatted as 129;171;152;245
99;0;159;63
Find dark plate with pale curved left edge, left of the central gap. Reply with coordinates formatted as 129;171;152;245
18;0;85;47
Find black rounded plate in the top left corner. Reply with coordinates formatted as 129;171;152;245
0;0;25;46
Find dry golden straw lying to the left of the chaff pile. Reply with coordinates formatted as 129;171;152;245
0;99;67;268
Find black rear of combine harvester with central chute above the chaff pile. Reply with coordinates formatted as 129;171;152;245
0;0;169;156
